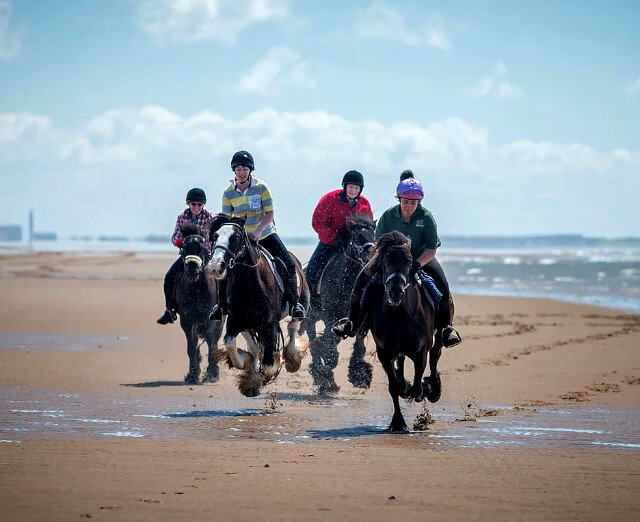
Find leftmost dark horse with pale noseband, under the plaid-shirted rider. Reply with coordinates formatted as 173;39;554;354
175;223;222;384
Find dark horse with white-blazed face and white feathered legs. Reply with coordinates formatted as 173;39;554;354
206;214;309;397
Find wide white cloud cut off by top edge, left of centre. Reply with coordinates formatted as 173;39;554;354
140;0;290;42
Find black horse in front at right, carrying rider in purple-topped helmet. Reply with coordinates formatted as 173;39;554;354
364;232;442;433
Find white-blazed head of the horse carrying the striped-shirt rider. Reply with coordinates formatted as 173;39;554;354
207;214;253;279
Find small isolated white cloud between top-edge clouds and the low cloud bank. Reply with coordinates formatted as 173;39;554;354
239;47;313;95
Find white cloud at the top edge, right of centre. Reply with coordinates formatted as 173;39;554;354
354;2;452;51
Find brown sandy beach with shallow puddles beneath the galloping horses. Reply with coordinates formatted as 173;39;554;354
0;250;640;520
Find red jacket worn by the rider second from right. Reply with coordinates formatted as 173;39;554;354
311;189;373;245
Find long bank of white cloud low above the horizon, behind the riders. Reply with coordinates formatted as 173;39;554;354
0;106;640;236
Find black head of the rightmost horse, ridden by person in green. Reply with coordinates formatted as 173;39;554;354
376;231;412;307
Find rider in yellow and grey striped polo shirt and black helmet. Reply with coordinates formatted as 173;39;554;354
214;150;305;319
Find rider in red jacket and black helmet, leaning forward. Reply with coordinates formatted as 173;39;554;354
305;170;373;305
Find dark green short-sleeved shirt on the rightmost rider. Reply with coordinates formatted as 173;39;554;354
376;205;440;259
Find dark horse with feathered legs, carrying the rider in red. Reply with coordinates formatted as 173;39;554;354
303;215;375;394
